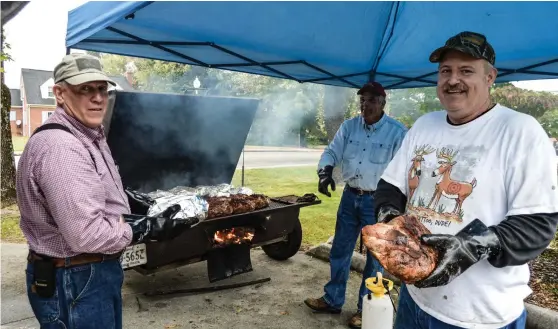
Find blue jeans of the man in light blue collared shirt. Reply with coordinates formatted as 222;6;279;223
324;186;384;310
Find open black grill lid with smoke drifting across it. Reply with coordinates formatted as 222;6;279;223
105;91;259;193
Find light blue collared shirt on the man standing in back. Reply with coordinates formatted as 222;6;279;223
318;114;407;191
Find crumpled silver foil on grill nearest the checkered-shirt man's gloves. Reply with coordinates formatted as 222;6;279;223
147;194;208;220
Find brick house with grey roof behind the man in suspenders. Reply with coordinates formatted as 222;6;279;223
10;69;134;136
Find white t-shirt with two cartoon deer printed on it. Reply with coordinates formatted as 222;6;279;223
382;104;558;328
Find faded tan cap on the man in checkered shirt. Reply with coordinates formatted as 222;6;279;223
54;53;116;86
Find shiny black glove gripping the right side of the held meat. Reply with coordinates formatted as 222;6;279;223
414;219;501;288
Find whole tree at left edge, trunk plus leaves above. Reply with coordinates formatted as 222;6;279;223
0;1;28;207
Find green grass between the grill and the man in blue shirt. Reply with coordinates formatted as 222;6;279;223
232;166;341;245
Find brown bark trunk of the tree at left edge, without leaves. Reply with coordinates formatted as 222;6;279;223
0;28;17;207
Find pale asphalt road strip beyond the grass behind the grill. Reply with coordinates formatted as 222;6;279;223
15;149;322;169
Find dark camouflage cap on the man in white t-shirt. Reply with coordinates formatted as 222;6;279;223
430;31;496;65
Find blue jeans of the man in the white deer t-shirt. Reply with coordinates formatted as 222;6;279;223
393;285;527;329
